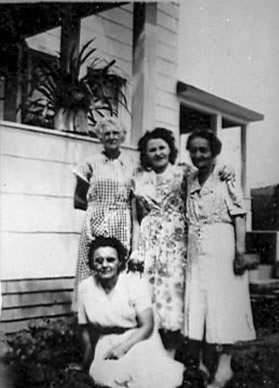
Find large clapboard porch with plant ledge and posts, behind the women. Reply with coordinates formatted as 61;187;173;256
0;2;179;332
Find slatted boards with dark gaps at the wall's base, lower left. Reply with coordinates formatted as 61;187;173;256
1;276;74;333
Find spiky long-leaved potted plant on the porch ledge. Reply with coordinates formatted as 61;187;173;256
22;39;127;133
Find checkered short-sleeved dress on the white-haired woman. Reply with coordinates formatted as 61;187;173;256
74;153;134;292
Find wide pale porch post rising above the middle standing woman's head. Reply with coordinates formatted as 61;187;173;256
131;2;157;145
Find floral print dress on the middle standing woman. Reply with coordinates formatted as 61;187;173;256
134;165;189;331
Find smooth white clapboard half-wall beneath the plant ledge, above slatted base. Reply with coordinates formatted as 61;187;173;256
0;122;138;279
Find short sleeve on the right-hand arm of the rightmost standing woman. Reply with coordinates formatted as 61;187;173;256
226;179;246;217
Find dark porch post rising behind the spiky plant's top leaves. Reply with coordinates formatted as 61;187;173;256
60;4;80;71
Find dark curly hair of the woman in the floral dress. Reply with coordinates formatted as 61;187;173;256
138;127;178;170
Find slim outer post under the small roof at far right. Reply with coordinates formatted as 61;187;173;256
240;124;252;231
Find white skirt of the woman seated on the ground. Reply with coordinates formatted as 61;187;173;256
89;329;184;388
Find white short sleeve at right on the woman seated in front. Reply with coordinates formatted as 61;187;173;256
130;274;152;314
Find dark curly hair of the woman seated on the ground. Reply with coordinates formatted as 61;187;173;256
88;236;127;271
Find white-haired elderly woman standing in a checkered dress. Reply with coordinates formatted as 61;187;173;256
73;117;137;308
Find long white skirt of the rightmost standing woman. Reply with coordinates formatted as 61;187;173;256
185;223;255;344
